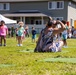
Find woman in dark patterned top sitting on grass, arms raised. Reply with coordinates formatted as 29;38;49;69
34;20;65;52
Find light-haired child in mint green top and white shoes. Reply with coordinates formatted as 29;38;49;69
18;22;24;46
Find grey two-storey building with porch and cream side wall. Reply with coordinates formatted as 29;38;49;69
0;0;76;31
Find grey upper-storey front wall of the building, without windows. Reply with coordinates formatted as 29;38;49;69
0;0;67;20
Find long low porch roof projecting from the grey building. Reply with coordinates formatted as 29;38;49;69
3;10;48;17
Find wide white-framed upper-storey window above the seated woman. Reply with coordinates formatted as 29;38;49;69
48;1;64;9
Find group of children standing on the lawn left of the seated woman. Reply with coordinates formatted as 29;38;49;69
0;20;37;46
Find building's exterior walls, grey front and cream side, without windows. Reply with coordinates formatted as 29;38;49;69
0;0;76;31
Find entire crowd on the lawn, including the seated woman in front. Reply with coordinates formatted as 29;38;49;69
0;18;76;52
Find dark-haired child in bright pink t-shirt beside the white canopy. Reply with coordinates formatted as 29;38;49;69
0;20;8;46
